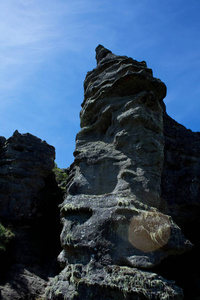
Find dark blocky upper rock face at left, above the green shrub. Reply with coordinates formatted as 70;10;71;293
0;131;55;221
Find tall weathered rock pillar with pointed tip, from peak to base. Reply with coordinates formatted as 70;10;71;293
47;45;200;300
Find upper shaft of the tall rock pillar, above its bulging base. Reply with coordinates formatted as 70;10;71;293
69;46;166;207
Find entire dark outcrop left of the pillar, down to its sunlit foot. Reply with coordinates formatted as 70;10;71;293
0;131;62;300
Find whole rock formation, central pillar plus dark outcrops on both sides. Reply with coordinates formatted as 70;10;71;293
0;45;200;300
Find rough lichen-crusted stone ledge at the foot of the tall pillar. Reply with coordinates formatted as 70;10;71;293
47;262;183;300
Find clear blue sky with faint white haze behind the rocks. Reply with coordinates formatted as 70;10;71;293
0;0;200;168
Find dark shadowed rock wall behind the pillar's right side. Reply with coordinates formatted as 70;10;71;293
162;113;200;227
